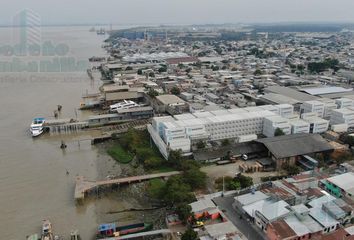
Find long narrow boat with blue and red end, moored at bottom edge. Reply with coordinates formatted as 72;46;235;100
97;223;153;239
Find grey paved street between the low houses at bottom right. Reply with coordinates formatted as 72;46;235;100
213;195;266;240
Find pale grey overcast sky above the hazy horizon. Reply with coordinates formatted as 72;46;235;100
0;0;354;24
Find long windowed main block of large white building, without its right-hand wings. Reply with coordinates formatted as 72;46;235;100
148;107;276;158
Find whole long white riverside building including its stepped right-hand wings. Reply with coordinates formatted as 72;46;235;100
148;104;328;159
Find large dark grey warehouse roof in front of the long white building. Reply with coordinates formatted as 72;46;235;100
255;133;333;158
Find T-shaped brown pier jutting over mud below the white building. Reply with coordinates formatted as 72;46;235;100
74;171;181;201
